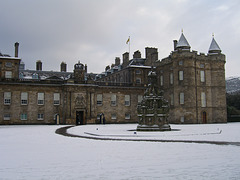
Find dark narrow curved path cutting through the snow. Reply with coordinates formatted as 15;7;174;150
55;126;240;146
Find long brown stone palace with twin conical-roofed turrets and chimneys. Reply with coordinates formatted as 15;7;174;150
0;33;227;125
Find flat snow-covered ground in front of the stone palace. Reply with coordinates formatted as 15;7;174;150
0;123;240;180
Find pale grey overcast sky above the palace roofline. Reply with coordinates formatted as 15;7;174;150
0;0;240;77
